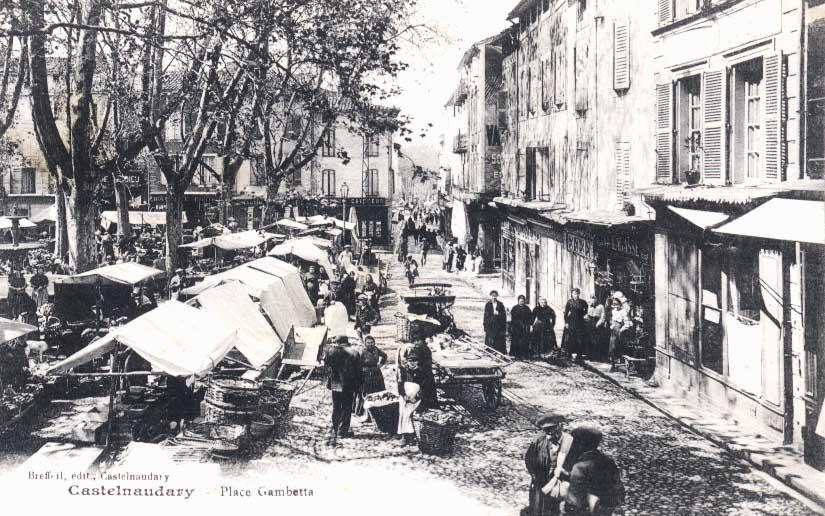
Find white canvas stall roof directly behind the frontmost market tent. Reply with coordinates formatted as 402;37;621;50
195;282;283;367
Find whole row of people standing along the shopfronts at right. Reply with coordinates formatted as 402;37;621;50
484;288;646;367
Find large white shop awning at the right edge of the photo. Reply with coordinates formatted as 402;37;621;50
714;199;825;245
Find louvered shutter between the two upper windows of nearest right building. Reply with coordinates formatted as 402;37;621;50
702;70;727;185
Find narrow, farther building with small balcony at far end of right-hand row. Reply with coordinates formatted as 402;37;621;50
445;31;510;267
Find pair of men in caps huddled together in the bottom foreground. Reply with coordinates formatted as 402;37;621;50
522;414;625;516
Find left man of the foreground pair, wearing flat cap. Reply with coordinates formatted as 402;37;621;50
522;414;564;516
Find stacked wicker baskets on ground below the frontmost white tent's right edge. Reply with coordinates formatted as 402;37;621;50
202;376;261;425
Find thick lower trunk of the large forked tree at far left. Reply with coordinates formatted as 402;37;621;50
66;181;98;273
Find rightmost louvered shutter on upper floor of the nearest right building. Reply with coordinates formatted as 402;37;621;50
763;54;785;182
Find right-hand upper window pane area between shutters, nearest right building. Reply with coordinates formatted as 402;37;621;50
731;58;764;184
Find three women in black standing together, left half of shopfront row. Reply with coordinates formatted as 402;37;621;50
484;290;556;358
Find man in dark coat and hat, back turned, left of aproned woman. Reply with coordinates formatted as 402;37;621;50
324;336;361;445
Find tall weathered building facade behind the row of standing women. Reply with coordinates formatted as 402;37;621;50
495;0;655;314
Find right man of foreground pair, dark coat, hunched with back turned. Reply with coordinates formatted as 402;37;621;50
561;427;625;516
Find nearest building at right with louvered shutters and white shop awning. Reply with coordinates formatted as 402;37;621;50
641;0;825;467
